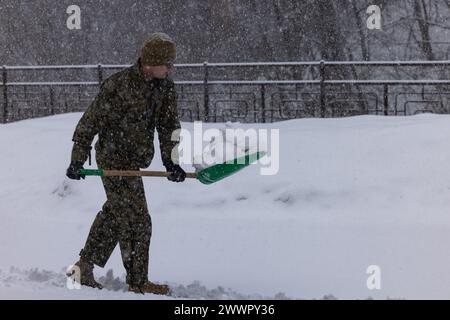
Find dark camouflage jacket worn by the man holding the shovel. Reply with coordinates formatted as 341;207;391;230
71;60;180;169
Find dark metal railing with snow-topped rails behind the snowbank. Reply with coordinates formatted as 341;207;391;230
0;61;450;123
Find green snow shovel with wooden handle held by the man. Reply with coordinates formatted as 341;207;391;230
78;151;266;184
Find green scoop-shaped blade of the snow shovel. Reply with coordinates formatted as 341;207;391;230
197;151;266;184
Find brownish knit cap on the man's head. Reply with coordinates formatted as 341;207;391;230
141;32;176;66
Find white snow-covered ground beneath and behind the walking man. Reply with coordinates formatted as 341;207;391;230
0;113;450;299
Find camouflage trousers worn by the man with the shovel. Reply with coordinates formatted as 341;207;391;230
80;164;152;285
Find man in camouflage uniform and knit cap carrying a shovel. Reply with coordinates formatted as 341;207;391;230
67;33;186;294
